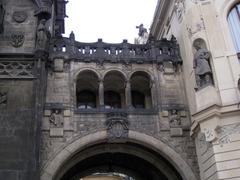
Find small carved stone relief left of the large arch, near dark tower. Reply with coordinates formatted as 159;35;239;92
49;109;63;128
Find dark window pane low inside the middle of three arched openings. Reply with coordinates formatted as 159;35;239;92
104;91;121;109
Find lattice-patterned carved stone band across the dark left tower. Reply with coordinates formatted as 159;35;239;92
0;61;34;78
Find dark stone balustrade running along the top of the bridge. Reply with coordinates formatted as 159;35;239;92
50;36;182;64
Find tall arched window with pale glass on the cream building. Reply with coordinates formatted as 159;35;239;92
228;3;240;54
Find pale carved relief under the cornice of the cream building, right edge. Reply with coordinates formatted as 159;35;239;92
216;123;240;146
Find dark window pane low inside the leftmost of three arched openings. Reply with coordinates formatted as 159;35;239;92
77;90;96;109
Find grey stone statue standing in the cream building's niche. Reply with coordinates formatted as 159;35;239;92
193;40;213;88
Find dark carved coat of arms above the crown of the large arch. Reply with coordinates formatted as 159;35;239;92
106;112;129;141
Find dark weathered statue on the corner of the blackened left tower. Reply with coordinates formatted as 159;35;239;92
36;19;51;50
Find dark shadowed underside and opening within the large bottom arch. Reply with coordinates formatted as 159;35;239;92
54;142;182;180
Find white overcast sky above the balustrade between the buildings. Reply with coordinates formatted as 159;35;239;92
64;0;158;43
